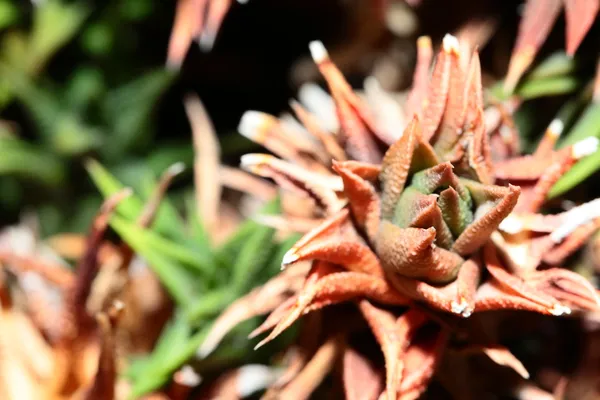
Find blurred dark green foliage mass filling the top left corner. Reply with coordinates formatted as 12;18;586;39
0;0;178;234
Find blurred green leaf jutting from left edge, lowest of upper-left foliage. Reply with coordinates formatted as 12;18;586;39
0;137;65;186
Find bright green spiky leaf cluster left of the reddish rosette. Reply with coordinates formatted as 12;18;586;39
87;161;298;398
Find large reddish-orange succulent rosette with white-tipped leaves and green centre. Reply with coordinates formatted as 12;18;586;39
201;35;600;399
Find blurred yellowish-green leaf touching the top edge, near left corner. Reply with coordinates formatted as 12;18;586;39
27;0;89;73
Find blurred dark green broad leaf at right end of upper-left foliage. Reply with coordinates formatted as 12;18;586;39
102;69;175;160
